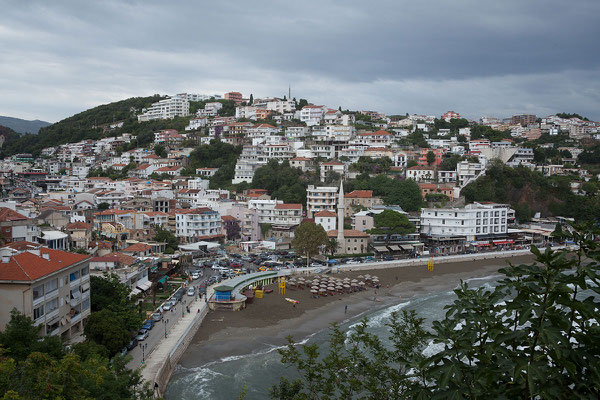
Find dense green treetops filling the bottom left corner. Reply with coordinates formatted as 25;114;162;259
0;311;153;400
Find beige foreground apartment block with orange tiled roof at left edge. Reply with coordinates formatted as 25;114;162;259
0;246;90;340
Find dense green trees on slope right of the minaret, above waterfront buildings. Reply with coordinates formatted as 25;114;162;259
346;175;423;211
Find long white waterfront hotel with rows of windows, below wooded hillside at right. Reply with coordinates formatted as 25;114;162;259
421;203;514;242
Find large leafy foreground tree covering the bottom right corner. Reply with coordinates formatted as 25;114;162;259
271;226;600;399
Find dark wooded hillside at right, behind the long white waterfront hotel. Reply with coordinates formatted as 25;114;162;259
462;162;600;222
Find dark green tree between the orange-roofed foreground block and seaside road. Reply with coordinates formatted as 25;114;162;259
84;275;143;356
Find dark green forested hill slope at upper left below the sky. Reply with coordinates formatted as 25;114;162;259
3;95;169;156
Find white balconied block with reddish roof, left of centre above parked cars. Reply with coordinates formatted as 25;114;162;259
175;208;221;243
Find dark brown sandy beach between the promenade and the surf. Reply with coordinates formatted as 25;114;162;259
180;255;533;367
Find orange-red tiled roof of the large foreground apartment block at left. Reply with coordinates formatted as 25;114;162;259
0;247;90;281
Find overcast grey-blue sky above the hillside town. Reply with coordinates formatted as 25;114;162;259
0;0;600;122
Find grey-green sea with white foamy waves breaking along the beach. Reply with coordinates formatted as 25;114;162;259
165;275;498;400
